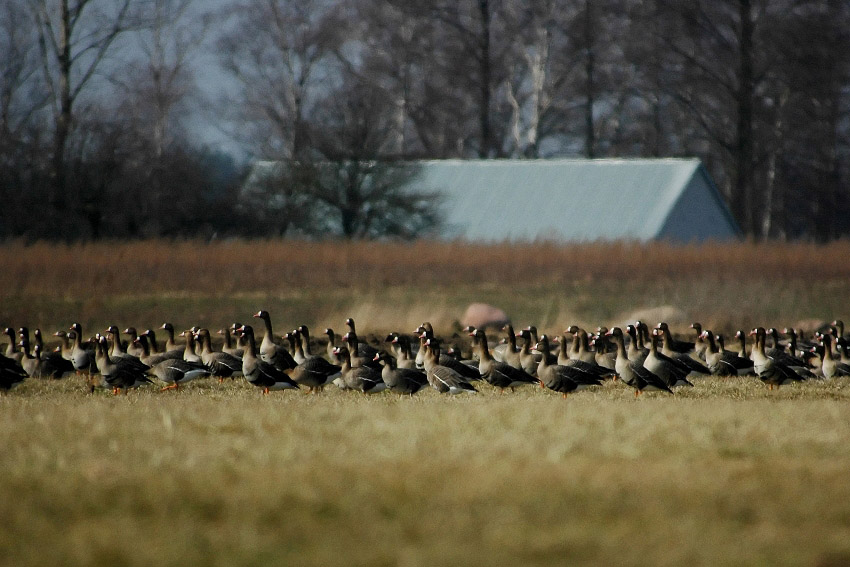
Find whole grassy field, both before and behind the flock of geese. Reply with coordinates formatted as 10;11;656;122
0;243;850;566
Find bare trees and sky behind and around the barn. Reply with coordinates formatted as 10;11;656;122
0;0;850;241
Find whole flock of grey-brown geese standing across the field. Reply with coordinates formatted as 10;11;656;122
0;311;850;397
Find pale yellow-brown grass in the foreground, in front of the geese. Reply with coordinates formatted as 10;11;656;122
0;379;850;566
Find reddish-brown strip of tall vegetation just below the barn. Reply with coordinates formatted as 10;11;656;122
0;241;850;297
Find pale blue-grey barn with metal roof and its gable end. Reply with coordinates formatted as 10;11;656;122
411;158;739;242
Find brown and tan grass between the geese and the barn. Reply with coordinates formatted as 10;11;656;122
0;241;850;340
